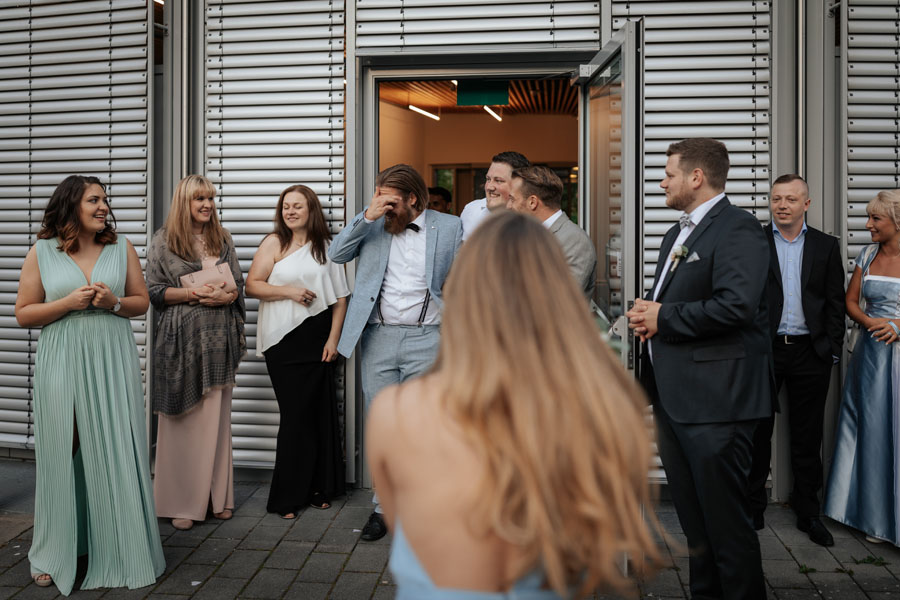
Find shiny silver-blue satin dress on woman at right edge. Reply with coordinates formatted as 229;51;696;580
825;244;900;545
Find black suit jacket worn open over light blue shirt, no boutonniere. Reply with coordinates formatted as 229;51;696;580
764;223;844;362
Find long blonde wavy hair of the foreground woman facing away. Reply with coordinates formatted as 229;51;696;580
434;211;661;597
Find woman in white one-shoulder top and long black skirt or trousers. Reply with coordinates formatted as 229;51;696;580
247;185;350;519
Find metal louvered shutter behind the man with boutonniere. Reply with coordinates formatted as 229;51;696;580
612;0;771;289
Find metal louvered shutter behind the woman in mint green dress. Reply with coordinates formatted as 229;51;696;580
0;0;151;448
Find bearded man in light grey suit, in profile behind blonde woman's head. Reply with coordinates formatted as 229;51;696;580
506;165;597;298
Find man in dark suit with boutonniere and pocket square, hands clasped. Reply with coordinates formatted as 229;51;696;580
627;138;774;600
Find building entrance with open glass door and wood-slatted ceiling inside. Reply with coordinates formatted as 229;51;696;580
348;22;643;485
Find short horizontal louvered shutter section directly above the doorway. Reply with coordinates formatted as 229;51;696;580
355;0;600;54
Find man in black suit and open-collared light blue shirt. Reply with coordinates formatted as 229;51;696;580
750;175;844;546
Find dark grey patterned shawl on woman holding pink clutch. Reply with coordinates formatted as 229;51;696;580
147;227;247;416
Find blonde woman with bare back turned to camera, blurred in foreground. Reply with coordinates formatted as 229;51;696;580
366;213;659;600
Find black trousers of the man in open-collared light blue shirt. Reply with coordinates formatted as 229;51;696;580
749;338;832;518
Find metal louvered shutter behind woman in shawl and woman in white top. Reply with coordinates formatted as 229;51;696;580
206;0;344;467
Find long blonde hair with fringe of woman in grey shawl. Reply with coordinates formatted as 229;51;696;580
166;175;226;260
